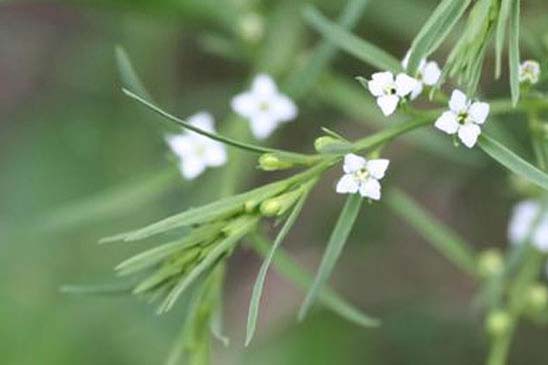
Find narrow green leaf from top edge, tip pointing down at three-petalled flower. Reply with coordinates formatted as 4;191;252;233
407;0;470;75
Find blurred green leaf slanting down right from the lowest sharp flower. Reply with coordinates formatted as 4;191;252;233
384;188;476;276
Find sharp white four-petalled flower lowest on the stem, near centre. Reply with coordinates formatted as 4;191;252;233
337;153;390;200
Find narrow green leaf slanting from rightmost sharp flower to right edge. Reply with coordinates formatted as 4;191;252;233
479;133;548;190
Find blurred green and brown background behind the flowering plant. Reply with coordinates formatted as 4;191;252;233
0;0;548;365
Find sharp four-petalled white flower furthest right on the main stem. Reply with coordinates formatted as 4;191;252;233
434;90;489;148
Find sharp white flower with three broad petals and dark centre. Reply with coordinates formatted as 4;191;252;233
367;71;418;116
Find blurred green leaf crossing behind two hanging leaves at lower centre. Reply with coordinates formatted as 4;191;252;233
253;234;380;327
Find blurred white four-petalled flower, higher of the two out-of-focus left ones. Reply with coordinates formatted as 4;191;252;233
231;74;297;139
